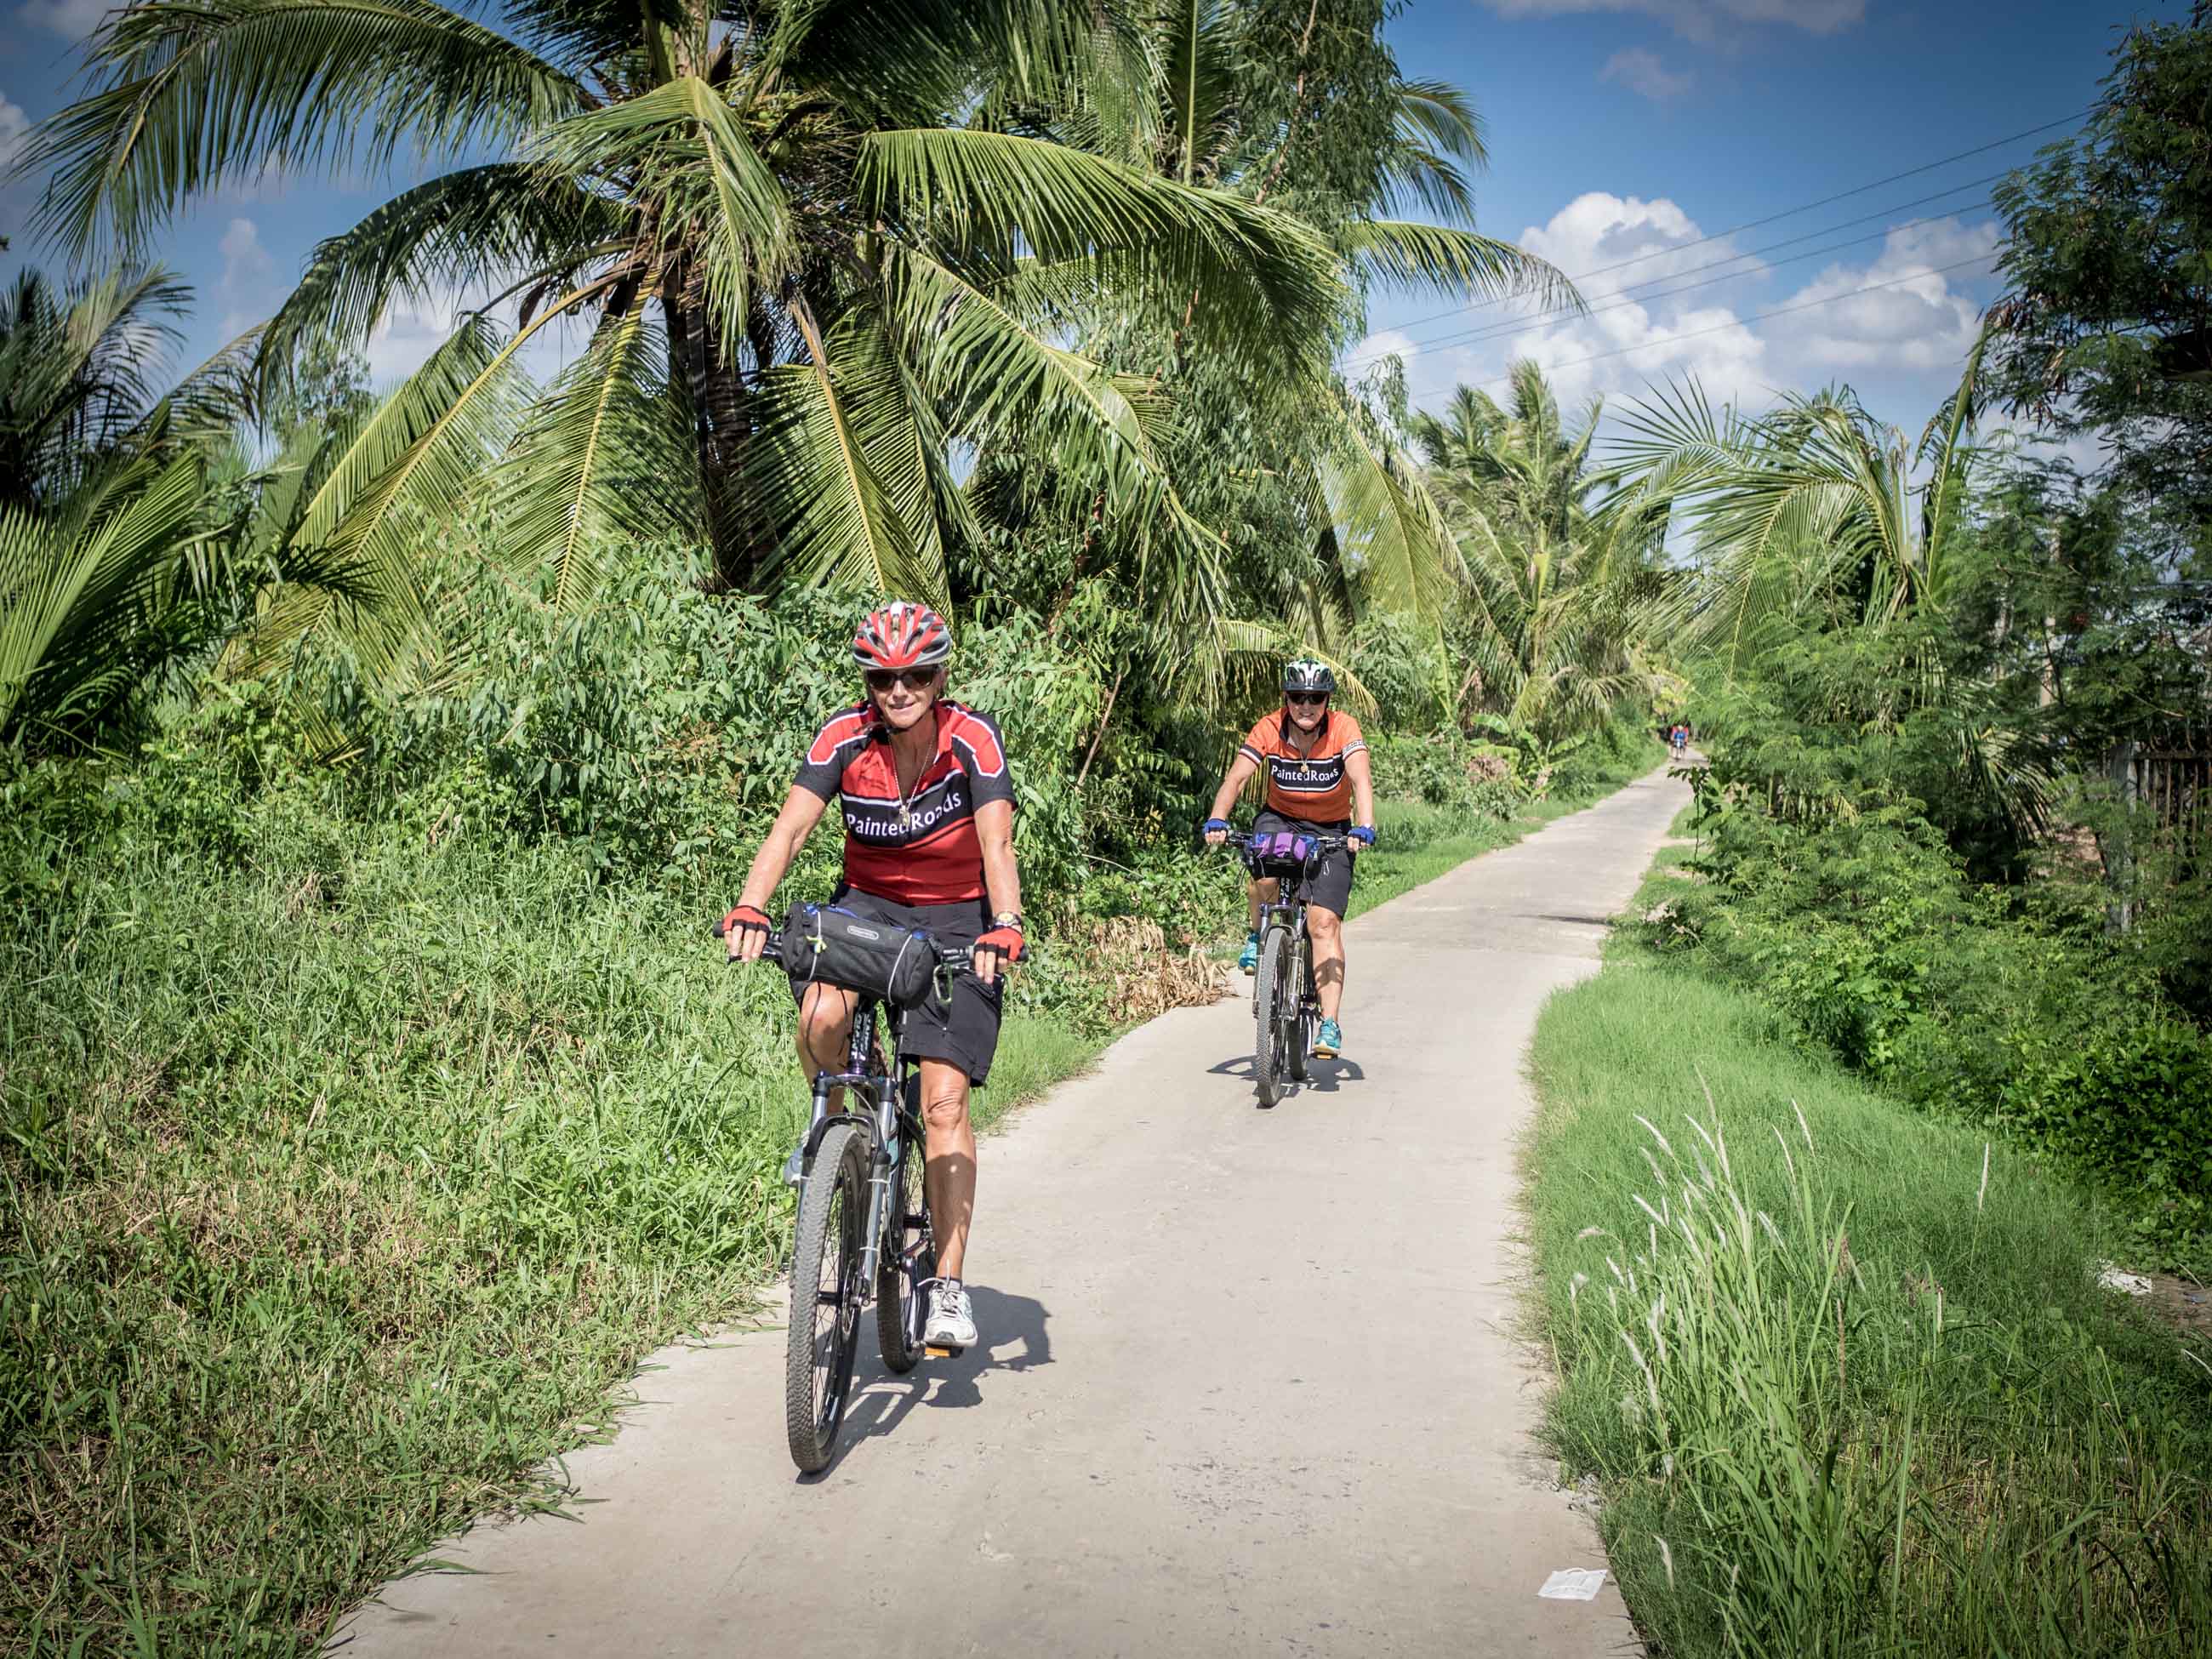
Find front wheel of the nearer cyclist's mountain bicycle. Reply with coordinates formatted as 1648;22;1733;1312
783;1124;867;1475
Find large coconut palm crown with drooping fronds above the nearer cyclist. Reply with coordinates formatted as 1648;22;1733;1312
22;0;1345;614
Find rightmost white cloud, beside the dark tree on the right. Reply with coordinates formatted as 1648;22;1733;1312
1774;217;1998;372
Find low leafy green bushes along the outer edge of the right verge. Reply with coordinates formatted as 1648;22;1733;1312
1641;738;2212;1263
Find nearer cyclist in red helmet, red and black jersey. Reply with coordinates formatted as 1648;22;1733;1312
723;600;1024;1347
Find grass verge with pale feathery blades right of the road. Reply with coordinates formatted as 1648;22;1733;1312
1526;849;2212;1656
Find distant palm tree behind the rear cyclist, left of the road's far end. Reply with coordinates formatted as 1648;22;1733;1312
1413;361;1670;745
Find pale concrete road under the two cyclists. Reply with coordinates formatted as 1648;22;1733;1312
340;772;1688;1659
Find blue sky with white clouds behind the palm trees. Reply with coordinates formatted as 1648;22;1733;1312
0;0;2186;437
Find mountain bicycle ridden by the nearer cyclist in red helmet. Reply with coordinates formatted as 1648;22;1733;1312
715;922;973;1475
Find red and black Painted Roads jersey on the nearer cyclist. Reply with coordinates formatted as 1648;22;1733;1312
796;699;1013;904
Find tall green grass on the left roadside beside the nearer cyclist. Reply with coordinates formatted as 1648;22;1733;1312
0;841;1095;1652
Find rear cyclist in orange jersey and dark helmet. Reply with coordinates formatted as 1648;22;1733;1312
1203;657;1376;1059
